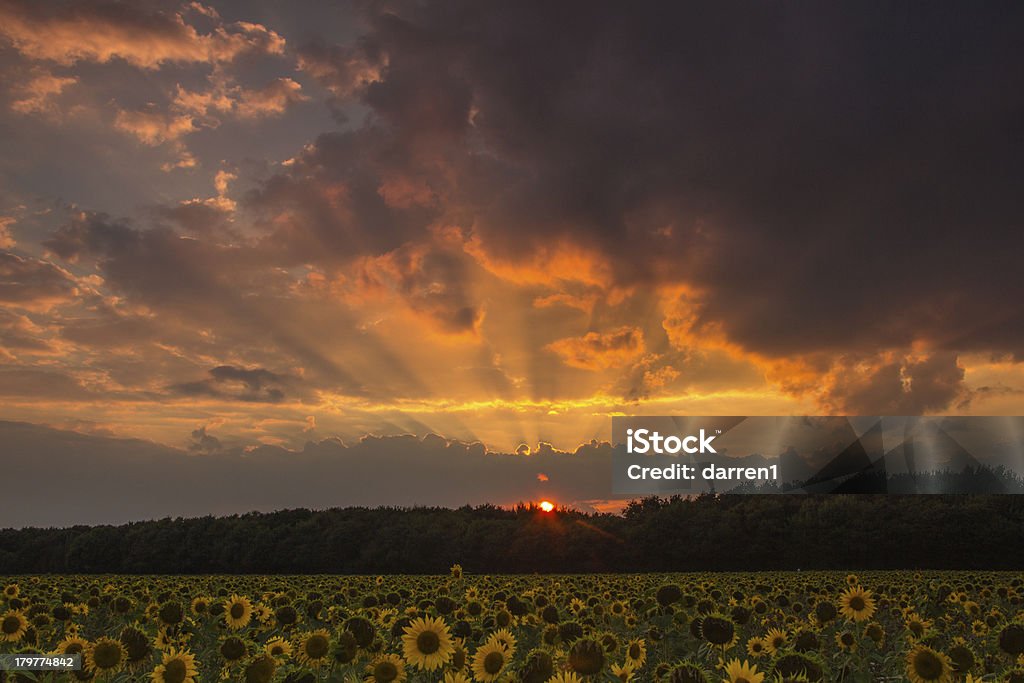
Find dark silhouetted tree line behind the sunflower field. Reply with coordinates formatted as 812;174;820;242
0;495;1024;574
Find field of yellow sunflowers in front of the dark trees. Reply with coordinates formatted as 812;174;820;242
0;566;1024;683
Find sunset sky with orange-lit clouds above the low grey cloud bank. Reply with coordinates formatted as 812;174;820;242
0;0;1024;524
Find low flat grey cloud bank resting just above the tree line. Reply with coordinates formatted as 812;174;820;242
0;422;611;527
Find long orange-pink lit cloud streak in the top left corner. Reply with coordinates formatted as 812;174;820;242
0;0;285;69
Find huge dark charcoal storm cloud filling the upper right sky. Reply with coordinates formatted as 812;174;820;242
307;2;1024;362
